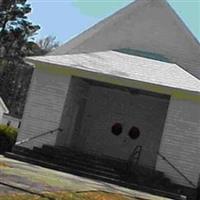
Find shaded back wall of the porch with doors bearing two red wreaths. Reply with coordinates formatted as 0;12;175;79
78;87;168;168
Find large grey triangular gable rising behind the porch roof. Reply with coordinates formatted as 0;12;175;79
49;0;200;78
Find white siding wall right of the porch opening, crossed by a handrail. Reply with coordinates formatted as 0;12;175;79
156;97;200;187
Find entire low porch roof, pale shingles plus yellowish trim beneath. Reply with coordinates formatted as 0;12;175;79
27;51;200;101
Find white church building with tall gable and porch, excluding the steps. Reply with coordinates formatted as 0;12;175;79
13;0;200;195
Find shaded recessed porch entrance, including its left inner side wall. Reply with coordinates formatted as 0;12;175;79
58;77;169;168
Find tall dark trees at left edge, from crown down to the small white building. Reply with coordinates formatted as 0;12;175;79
0;0;39;117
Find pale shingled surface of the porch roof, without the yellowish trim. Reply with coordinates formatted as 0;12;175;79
28;51;200;93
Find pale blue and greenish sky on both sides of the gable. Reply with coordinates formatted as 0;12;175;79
28;0;200;44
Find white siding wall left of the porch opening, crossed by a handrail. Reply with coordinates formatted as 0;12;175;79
17;69;70;148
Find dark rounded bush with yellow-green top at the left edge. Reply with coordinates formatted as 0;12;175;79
0;125;17;153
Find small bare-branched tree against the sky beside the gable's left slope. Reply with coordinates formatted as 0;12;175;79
37;36;59;55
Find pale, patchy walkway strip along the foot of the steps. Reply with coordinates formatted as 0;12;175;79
0;156;172;200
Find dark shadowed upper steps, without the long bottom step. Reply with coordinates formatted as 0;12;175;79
12;145;174;189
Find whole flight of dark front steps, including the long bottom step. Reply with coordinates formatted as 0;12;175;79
5;145;197;200
